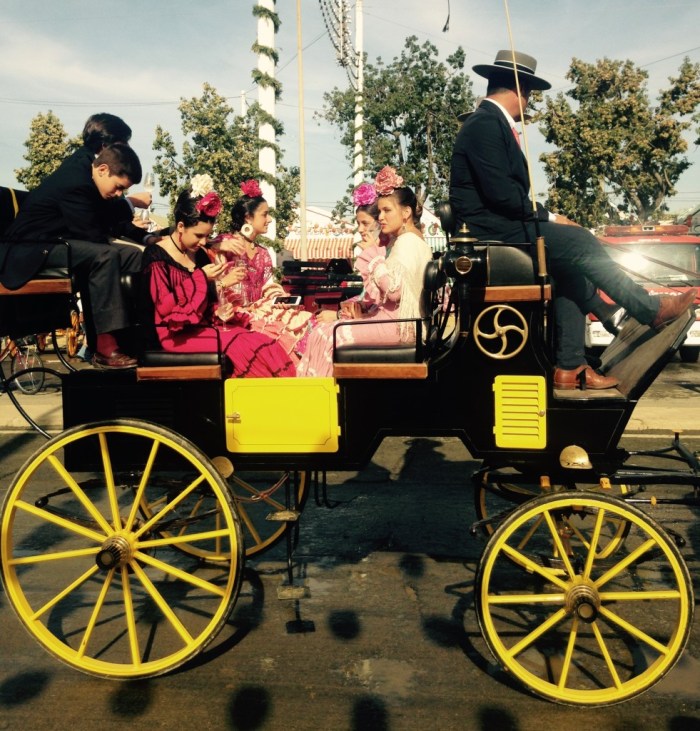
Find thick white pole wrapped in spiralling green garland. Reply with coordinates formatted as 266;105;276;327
257;0;277;246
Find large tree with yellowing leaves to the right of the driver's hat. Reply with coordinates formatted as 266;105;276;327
535;58;700;226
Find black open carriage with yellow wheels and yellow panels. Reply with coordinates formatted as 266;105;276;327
0;193;700;704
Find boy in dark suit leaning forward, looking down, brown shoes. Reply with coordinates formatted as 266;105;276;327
0;142;141;368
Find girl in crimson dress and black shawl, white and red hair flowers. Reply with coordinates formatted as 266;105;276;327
142;175;294;378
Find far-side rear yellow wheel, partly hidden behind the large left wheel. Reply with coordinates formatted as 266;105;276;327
140;466;308;562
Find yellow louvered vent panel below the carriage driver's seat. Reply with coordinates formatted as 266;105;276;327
493;376;547;449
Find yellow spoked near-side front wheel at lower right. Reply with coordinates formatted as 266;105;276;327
476;492;693;705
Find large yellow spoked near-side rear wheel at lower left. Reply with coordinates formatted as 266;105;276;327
1;419;243;678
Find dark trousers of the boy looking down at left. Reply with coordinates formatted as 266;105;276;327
47;240;142;340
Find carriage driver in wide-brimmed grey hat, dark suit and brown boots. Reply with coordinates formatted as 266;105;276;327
450;51;697;388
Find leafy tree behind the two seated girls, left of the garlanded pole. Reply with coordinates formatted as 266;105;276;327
153;84;299;245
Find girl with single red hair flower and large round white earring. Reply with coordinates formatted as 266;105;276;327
209;180;312;362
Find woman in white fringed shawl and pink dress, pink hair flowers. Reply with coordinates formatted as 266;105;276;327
297;166;432;376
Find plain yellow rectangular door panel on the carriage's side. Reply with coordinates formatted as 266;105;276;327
224;378;340;453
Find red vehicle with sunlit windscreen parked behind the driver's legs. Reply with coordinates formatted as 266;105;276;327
586;224;700;363
